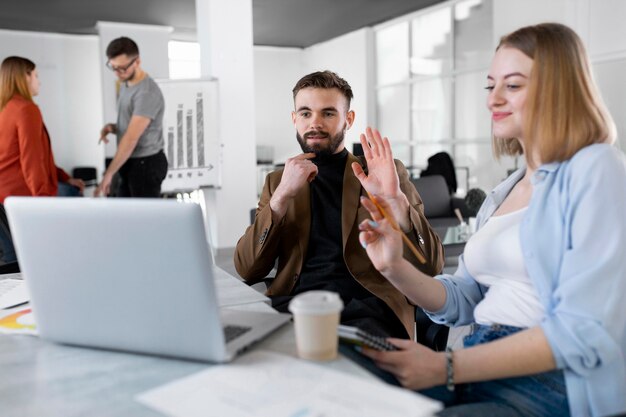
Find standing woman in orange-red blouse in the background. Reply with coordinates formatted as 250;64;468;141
0;56;85;203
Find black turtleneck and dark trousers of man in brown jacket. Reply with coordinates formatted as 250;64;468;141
272;149;407;338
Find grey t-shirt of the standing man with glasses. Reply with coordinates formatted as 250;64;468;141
117;76;165;158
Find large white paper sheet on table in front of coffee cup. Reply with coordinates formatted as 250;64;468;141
136;351;441;417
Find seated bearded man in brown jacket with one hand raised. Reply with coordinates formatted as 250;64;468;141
234;71;443;339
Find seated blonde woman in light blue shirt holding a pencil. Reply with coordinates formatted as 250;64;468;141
360;24;626;416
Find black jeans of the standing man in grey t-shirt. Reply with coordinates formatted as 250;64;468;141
116;151;167;197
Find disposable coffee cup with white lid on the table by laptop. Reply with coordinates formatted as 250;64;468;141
289;291;343;361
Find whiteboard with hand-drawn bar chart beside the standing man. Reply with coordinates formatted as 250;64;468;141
157;80;222;192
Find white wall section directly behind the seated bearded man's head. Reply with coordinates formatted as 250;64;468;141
254;28;372;166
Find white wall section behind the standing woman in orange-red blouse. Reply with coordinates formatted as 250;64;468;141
0;30;104;174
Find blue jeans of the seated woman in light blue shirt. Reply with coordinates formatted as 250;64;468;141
420;325;569;417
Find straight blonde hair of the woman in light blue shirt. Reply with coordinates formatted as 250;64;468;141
493;23;617;164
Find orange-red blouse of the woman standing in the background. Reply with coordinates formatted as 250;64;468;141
0;95;70;203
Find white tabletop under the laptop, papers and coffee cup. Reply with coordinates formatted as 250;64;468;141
0;272;375;417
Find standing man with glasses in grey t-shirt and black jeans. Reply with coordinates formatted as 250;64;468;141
95;37;167;197
